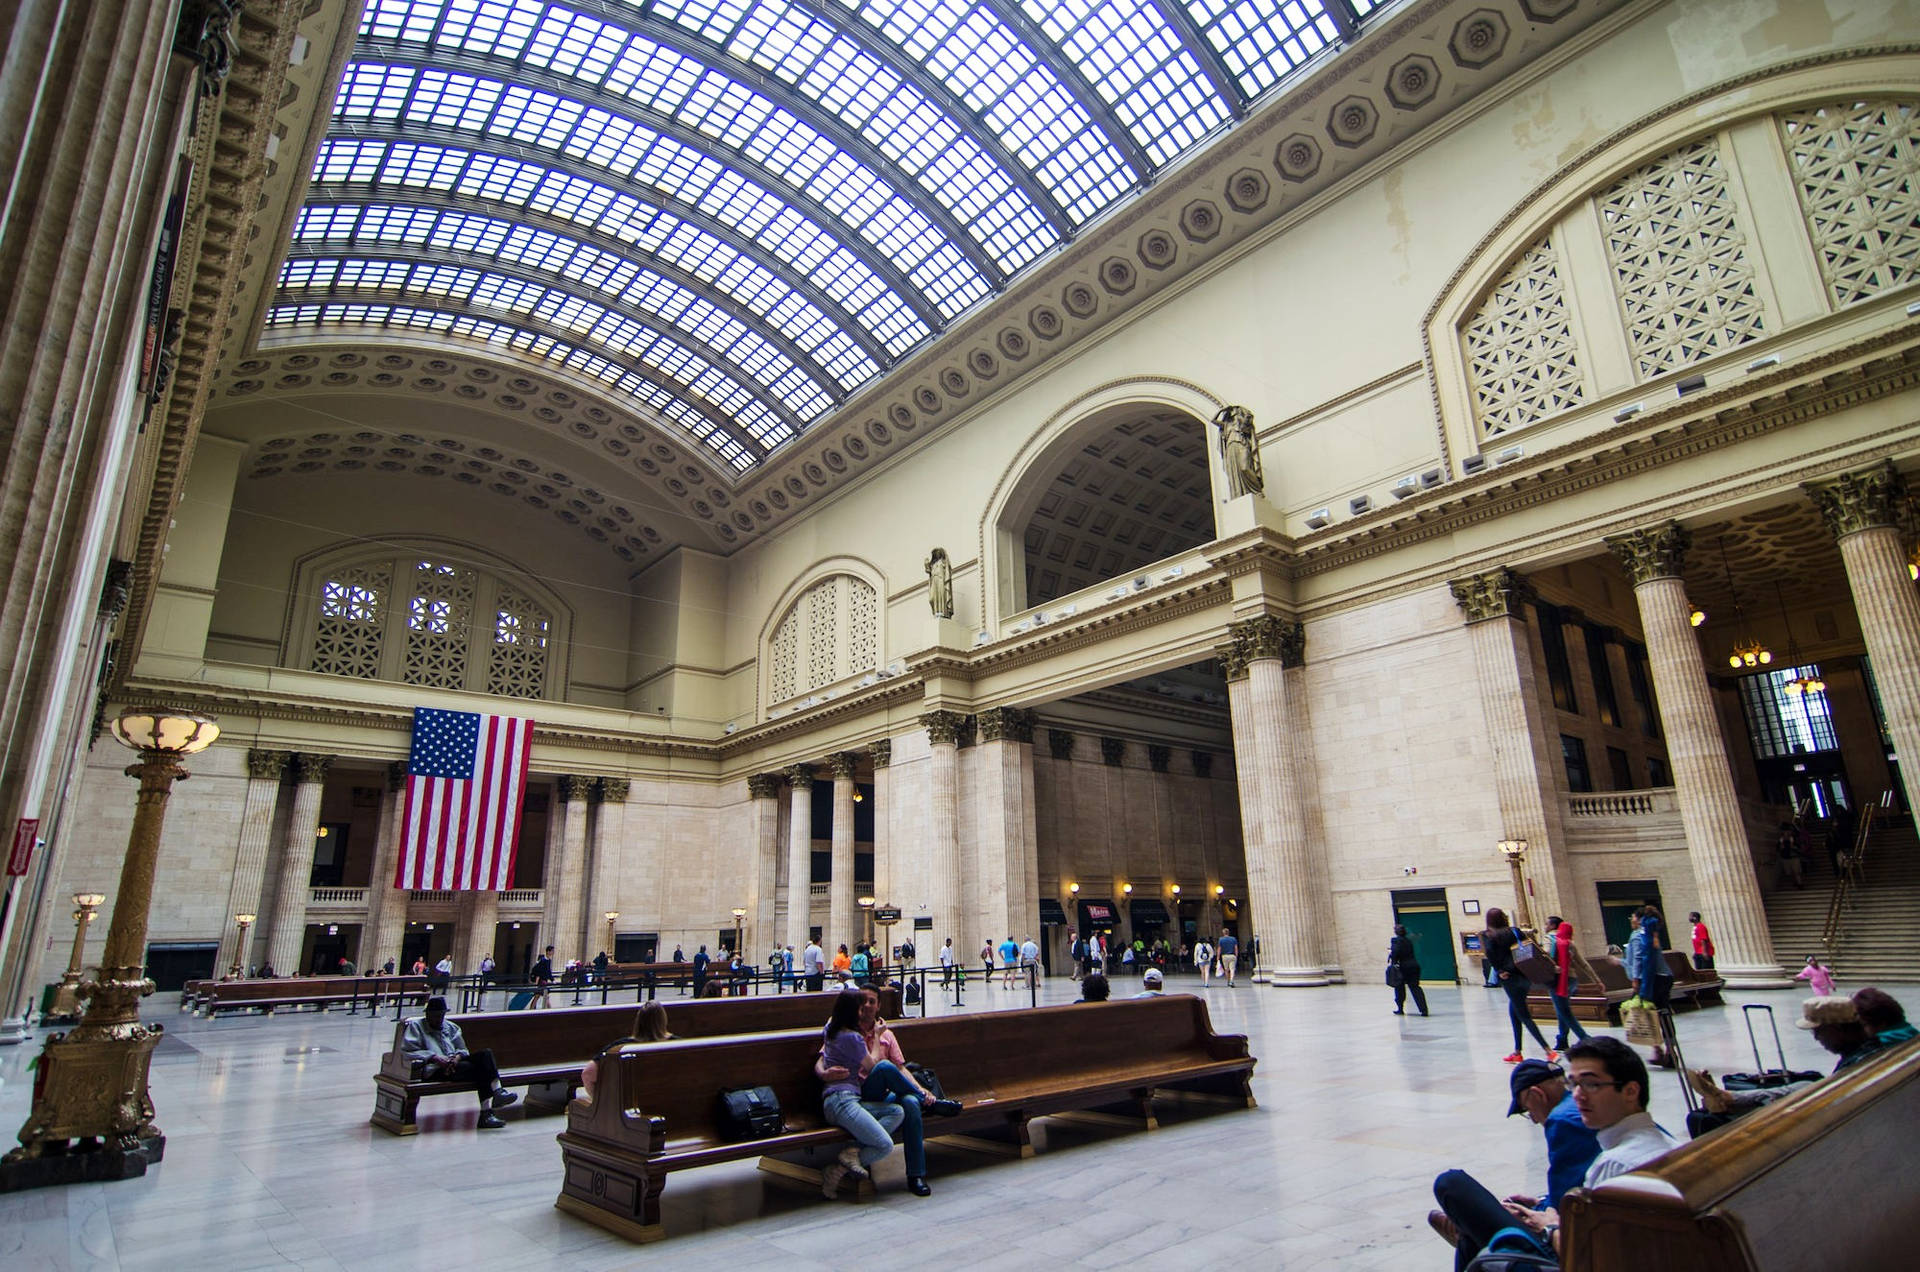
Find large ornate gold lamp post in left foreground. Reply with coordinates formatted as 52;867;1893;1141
0;711;221;1191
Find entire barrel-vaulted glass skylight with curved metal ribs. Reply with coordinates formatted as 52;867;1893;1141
267;0;1380;473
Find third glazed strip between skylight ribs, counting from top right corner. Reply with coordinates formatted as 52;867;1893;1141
1021;0;1233;167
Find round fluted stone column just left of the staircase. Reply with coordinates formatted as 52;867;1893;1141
1607;521;1791;990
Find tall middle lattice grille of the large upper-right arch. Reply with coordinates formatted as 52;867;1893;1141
1596;138;1766;379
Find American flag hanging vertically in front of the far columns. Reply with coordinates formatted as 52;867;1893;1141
394;707;534;892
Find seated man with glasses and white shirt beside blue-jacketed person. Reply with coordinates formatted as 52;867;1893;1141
1434;1036;1678;1257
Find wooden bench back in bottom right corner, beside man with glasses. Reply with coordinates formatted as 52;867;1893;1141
1561;1041;1920;1272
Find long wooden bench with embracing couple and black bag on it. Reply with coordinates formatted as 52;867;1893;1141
555;993;1254;1241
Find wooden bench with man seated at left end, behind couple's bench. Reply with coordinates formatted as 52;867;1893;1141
369;990;900;1136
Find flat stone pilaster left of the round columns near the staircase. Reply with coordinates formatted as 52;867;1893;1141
1448;569;1571;933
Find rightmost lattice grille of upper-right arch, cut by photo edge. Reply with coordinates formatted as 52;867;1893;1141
1780;102;1920;309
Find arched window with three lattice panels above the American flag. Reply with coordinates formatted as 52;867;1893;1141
286;550;564;697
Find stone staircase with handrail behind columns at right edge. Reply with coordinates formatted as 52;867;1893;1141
1766;820;1920;991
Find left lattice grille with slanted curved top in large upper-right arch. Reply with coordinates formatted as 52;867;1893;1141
1461;238;1584;438
